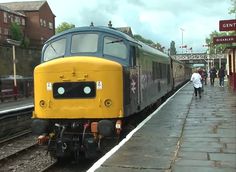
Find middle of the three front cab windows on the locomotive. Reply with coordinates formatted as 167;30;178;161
71;34;98;53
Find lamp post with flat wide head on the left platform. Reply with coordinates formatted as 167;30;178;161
6;39;21;100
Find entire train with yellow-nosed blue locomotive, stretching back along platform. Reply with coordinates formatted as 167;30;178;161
32;26;191;158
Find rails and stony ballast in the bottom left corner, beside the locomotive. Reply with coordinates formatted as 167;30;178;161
0;131;56;172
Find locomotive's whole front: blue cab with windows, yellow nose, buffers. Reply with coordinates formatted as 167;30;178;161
32;27;132;158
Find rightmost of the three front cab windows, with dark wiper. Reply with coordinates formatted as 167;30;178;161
103;37;127;59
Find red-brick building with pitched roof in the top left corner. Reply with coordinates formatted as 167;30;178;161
0;1;55;47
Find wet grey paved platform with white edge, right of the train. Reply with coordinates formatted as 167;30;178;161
88;81;236;172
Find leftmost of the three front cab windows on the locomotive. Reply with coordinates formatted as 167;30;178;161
43;38;66;61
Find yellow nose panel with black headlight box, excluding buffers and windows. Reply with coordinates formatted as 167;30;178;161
33;57;123;119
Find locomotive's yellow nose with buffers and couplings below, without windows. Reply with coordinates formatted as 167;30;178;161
33;56;123;158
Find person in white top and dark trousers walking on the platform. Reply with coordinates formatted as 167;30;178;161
190;69;202;98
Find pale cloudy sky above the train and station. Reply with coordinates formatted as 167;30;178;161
0;0;236;53
